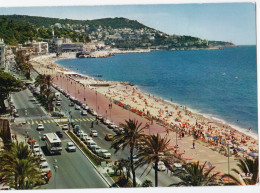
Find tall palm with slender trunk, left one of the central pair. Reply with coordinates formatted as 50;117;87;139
111;119;144;187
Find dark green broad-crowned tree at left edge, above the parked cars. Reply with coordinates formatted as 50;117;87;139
0;70;23;112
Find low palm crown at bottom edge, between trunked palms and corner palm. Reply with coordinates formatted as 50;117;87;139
169;162;219;186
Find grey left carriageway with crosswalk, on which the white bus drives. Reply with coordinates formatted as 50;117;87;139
9;90;108;189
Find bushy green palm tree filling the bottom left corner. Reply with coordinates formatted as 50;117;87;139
0;142;44;190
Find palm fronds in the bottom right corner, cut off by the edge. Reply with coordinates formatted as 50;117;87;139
223;157;259;185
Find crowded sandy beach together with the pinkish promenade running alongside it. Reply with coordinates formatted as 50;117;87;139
31;53;258;179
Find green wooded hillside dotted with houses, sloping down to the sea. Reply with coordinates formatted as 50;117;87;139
0;15;234;50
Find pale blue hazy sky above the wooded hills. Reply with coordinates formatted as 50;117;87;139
0;3;256;45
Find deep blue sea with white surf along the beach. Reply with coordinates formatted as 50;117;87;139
56;46;258;137
